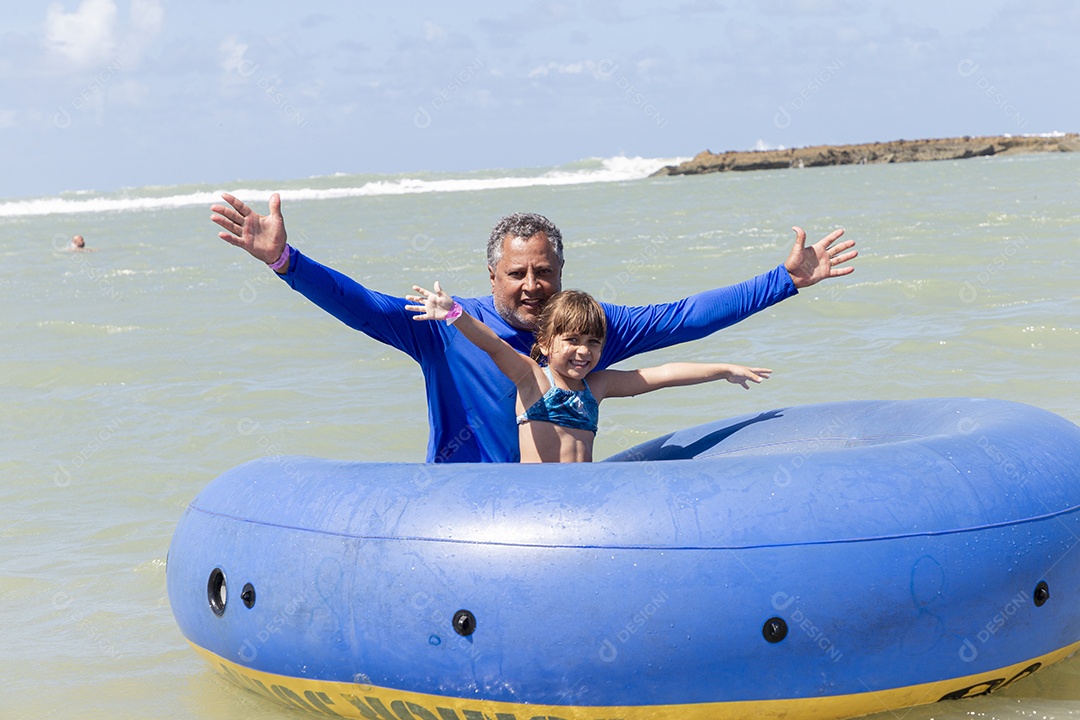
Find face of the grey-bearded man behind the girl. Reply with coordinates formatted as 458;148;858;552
487;232;563;330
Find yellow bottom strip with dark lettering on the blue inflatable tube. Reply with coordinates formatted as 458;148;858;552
192;642;1080;720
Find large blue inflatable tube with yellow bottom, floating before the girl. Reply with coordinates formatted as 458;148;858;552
167;398;1080;720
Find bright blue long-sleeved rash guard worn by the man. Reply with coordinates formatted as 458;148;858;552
282;248;798;462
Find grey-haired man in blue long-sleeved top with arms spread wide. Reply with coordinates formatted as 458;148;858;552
211;193;858;462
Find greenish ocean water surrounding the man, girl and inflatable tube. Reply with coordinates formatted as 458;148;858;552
0;148;1080;720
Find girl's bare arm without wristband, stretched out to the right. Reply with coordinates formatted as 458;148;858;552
589;363;772;400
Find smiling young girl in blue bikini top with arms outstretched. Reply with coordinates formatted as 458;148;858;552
405;282;772;462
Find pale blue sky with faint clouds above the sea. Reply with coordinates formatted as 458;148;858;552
0;0;1080;199
